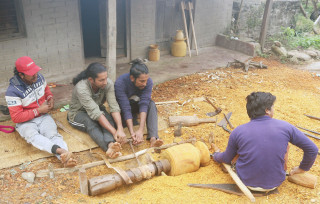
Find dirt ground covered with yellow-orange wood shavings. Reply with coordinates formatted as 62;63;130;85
0;58;320;203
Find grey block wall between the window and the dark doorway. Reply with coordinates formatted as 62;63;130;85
0;0;84;97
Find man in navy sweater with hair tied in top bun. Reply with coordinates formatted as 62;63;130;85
115;59;163;147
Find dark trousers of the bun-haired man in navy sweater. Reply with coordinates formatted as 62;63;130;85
122;100;159;140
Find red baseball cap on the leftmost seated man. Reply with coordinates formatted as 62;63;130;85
16;56;41;76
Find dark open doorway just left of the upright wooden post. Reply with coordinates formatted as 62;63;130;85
80;0;101;57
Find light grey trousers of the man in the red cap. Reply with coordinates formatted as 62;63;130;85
16;114;68;159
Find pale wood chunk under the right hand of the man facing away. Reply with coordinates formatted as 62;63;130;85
288;172;317;189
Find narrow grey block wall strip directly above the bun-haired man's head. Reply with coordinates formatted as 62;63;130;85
130;0;156;59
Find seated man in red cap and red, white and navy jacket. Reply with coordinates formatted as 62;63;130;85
6;56;77;167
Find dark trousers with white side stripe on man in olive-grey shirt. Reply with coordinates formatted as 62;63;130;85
68;110;115;151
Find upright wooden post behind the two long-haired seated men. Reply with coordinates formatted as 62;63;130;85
106;0;117;81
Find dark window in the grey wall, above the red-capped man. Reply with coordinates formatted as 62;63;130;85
0;0;26;41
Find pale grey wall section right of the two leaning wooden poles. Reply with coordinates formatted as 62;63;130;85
194;0;233;47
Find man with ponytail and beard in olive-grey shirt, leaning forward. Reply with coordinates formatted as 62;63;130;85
68;63;127;158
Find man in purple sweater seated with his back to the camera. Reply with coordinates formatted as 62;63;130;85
213;92;318;191
